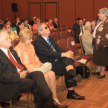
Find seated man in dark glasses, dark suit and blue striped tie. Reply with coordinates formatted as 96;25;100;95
34;23;85;100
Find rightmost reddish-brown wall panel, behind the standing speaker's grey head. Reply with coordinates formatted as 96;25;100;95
94;0;108;18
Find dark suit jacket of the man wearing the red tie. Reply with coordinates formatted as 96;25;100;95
0;49;26;102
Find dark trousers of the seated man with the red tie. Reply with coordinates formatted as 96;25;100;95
20;71;52;105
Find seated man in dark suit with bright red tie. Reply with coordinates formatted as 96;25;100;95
0;30;64;108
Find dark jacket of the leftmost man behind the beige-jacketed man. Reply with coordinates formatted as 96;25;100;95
72;23;80;42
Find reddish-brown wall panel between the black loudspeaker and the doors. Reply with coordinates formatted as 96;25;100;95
15;0;28;19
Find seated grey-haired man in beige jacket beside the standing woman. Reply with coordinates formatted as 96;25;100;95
82;22;93;54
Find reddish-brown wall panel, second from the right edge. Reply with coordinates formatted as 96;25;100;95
76;0;93;21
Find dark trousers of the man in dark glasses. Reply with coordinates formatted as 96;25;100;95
52;58;77;88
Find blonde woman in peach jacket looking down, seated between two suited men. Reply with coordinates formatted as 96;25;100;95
15;29;63;105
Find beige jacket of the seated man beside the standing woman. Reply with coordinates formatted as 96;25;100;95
82;30;93;55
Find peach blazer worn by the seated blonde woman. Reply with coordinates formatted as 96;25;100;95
14;42;42;72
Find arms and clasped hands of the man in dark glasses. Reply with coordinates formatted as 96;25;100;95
34;40;74;58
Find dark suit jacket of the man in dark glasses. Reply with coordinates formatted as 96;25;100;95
34;36;66;65
